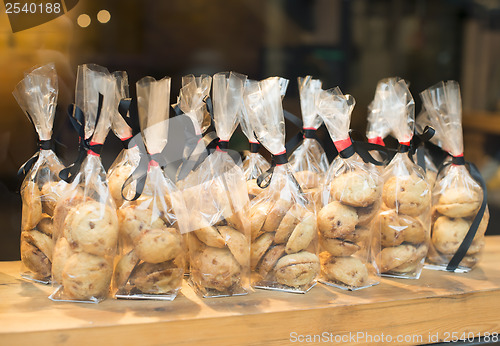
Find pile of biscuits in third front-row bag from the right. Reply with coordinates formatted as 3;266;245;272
318;168;381;288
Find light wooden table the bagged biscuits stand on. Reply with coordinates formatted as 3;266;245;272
0;236;500;346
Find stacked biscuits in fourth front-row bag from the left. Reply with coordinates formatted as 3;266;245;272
188;182;250;297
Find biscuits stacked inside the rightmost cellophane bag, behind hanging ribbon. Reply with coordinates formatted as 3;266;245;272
428;186;489;268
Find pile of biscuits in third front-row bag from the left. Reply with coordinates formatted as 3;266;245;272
113;195;185;296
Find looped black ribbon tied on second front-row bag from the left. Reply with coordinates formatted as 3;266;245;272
59;93;104;183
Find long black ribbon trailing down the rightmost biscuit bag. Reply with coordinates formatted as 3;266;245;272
438;156;488;272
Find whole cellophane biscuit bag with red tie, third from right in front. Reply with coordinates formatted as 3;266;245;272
318;87;382;290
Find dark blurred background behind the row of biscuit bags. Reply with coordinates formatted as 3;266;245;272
0;0;500;260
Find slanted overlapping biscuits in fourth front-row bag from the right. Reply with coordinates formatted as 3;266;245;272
250;199;320;289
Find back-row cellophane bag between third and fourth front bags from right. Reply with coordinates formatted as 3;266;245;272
289;76;329;206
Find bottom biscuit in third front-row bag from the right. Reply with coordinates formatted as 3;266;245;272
321;256;368;287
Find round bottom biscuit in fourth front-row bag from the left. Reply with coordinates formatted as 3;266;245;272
191;247;241;292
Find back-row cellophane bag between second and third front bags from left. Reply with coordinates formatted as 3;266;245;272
107;71;140;208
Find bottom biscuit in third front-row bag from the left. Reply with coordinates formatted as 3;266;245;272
130;261;183;294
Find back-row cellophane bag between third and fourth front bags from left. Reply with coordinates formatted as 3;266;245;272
173;74;212;188
